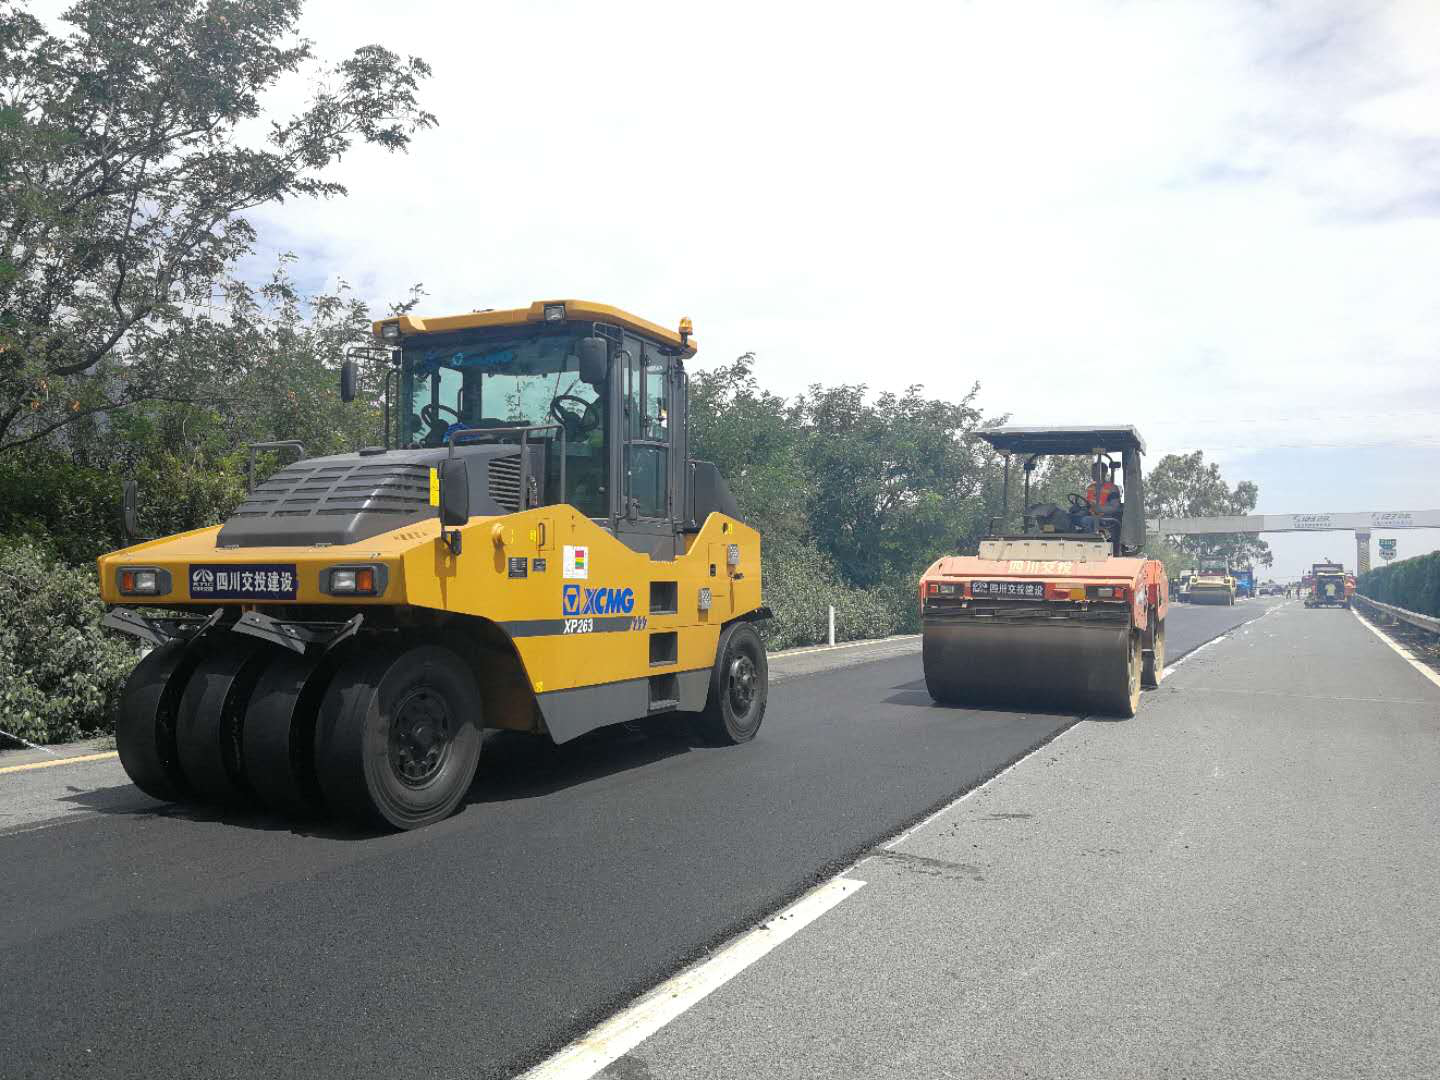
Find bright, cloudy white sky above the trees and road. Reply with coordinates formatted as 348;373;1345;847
30;0;1440;576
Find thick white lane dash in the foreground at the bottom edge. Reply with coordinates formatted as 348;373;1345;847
520;877;865;1080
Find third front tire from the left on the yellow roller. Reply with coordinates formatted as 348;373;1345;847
240;652;336;816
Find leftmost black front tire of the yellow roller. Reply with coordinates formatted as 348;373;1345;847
115;642;203;802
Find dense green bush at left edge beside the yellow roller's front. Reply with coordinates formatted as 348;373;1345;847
0;537;138;743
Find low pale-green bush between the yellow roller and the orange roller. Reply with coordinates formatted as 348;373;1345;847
762;540;916;649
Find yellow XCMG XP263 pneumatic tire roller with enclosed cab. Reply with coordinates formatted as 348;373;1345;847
99;300;768;828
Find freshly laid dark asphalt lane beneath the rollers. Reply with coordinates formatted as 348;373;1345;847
0;600;1272;1080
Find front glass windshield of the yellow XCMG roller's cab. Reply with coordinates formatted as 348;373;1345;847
399;324;609;517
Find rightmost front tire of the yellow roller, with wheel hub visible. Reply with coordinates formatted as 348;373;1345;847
315;644;484;829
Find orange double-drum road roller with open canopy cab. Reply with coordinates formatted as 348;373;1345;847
919;428;1169;716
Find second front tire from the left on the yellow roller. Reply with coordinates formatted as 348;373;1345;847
176;635;267;805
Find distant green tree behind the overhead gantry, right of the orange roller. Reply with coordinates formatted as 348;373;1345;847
1145;451;1274;566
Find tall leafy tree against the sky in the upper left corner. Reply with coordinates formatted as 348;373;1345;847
0;0;435;452
